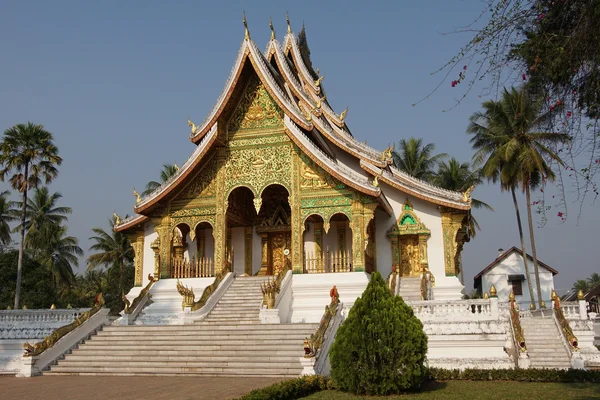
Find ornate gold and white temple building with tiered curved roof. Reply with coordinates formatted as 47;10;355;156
115;17;471;299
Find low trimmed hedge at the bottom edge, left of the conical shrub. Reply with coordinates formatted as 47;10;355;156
236;376;333;400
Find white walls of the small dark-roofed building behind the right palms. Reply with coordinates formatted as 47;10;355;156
481;252;554;309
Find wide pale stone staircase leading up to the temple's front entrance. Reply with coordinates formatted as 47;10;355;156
44;277;318;377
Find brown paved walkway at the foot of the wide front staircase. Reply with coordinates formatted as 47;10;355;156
0;376;282;400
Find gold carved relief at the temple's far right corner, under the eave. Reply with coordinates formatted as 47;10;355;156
441;210;467;276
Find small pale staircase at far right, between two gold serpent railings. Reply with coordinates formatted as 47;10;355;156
521;316;571;369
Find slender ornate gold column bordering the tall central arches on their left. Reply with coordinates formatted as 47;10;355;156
213;149;229;273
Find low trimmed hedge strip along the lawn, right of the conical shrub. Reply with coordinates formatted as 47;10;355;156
429;368;600;383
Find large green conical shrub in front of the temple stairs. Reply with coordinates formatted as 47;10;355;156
330;272;427;395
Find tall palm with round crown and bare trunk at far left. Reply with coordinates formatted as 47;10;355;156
0;122;62;309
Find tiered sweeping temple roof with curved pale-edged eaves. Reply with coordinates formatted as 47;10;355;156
116;21;471;231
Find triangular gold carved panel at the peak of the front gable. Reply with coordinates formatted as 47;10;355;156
228;75;283;132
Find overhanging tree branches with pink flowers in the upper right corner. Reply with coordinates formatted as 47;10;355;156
436;0;600;210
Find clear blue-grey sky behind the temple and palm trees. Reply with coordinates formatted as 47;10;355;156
0;0;600;289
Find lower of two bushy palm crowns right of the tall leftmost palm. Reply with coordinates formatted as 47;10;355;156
36;224;83;286
